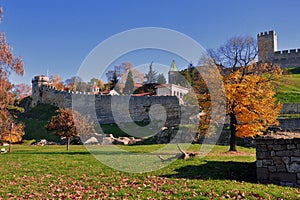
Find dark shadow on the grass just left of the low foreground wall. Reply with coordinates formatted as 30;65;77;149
164;161;257;183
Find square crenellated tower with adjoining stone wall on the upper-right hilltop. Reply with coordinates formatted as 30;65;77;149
257;30;300;67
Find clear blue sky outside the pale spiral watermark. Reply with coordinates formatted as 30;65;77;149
0;0;300;84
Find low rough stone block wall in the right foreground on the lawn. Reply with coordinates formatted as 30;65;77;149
255;138;300;188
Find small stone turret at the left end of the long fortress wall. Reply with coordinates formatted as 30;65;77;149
31;75;49;107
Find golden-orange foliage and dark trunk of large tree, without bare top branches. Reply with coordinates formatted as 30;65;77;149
224;63;281;151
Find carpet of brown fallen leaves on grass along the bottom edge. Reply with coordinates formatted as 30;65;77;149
0;174;298;199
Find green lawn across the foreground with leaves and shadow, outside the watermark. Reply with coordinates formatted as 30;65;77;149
0;145;300;199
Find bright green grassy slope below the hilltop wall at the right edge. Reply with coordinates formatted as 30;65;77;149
276;67;300;103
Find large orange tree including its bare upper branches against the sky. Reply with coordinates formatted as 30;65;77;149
209;36;282;151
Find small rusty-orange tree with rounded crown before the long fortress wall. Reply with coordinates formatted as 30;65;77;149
46;108;95;150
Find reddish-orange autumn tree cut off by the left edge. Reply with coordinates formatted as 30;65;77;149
0;7;24;148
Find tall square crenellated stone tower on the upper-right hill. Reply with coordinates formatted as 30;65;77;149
257;31;277;62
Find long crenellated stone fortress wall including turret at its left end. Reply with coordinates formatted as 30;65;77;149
31;76;181;126
